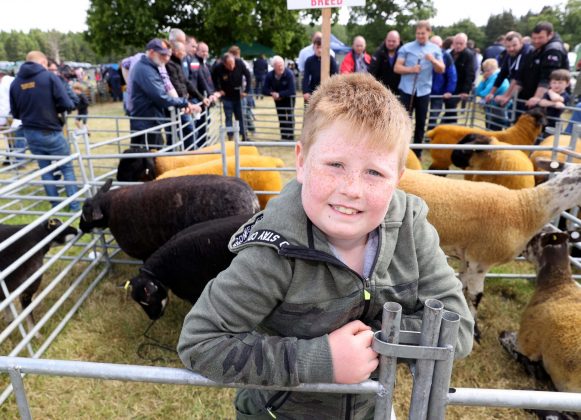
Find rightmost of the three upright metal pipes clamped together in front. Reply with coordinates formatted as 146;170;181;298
428;311;460;419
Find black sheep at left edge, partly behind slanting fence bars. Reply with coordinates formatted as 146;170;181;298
0;219;78;328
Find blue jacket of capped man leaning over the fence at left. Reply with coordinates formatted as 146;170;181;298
131;55;188;128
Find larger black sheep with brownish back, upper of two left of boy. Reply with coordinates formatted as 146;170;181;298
79;175;259;261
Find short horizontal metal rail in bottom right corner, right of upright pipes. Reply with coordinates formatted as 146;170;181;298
448;388;581;411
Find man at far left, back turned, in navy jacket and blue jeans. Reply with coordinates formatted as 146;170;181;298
10;51;80;211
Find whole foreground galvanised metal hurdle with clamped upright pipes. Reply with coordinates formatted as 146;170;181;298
0;299;581;420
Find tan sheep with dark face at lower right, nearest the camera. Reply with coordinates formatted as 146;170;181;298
500;229;581;392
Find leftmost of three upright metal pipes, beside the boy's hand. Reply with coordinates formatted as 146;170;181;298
372;302;401;420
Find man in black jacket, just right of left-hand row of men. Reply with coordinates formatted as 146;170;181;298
214;53;252;141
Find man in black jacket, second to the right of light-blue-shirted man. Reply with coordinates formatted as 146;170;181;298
443;32;476;124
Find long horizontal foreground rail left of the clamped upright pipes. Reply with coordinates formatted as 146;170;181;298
0;356;379;394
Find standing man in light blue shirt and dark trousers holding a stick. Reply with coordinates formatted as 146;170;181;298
394;20;446;158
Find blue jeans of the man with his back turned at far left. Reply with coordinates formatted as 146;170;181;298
22;128;80;211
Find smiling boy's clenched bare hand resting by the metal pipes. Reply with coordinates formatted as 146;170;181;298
329;321;379;384
